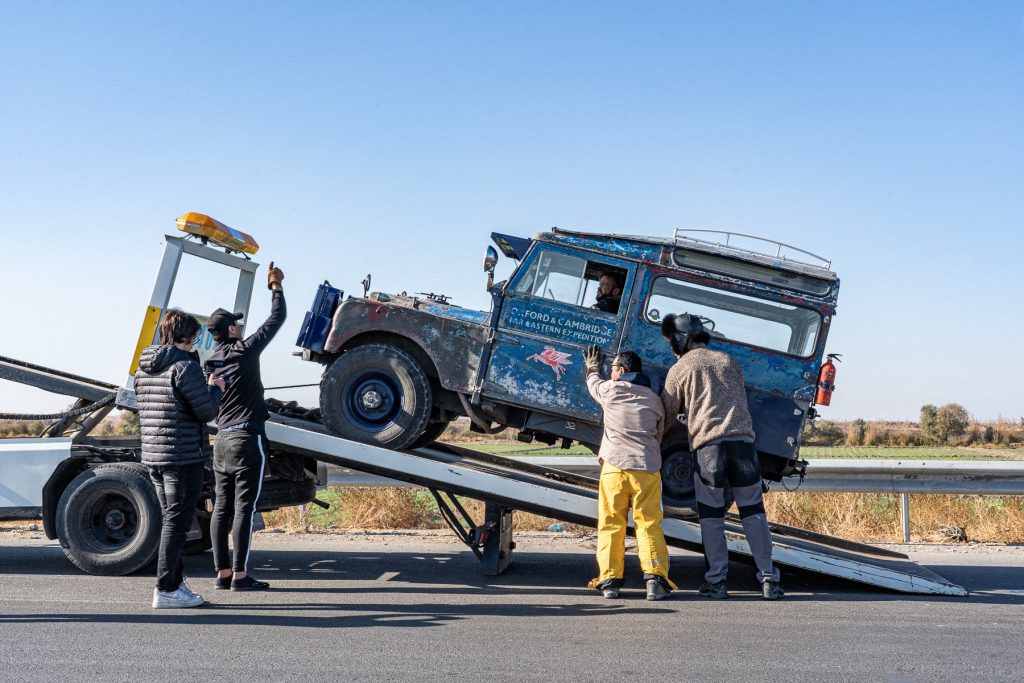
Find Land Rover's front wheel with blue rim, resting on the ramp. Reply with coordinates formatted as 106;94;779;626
321;344;433;450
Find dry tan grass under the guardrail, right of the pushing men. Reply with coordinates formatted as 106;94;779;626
765;492;1024;543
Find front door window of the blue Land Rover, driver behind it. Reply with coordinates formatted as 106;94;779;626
515;251;626;313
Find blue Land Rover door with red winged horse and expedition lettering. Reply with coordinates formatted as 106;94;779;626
483;243;635;422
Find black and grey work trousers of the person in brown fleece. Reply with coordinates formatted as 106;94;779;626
693;441;779;584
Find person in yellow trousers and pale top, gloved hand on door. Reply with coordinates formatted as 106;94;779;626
585;346;676;600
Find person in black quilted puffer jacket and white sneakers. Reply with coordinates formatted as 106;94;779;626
135;308;224;609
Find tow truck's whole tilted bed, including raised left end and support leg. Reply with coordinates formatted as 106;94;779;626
0;356;968;596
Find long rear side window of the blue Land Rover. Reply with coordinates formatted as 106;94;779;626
644;278;821;357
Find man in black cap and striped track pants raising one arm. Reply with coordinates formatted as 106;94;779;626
206;261;286;591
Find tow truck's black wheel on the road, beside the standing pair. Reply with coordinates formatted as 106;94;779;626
56;463;161;577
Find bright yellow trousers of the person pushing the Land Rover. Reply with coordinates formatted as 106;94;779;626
596;463;676;588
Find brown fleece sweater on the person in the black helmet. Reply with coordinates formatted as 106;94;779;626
662;345;754;451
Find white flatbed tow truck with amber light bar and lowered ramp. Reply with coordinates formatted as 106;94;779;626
0;214;967;596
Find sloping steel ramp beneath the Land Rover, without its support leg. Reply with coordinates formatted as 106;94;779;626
266;416;968;596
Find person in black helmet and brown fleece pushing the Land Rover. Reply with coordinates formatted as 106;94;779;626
662;313;782;600
